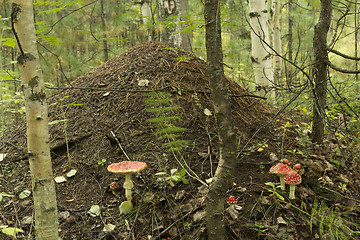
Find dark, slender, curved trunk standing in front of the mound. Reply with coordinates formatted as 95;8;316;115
204;0;236;240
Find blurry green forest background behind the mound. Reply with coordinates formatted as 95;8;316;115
0;0;360;136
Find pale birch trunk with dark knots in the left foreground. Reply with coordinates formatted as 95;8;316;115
11;0;58;240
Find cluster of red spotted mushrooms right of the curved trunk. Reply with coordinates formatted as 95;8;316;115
270;158;305;199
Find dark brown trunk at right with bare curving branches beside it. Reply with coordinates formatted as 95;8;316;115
312;0;332;144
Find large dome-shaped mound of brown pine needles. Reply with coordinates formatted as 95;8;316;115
0;42;282;239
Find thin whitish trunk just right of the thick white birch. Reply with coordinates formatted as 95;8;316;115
272;0;282;96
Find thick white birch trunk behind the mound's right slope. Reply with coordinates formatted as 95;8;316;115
249;0;275;101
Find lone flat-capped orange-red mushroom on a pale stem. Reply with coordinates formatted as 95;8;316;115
108;161;146;201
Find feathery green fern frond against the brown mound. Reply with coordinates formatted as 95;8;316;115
145;91;188;151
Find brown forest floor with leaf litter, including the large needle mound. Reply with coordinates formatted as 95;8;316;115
0;42;360;240
